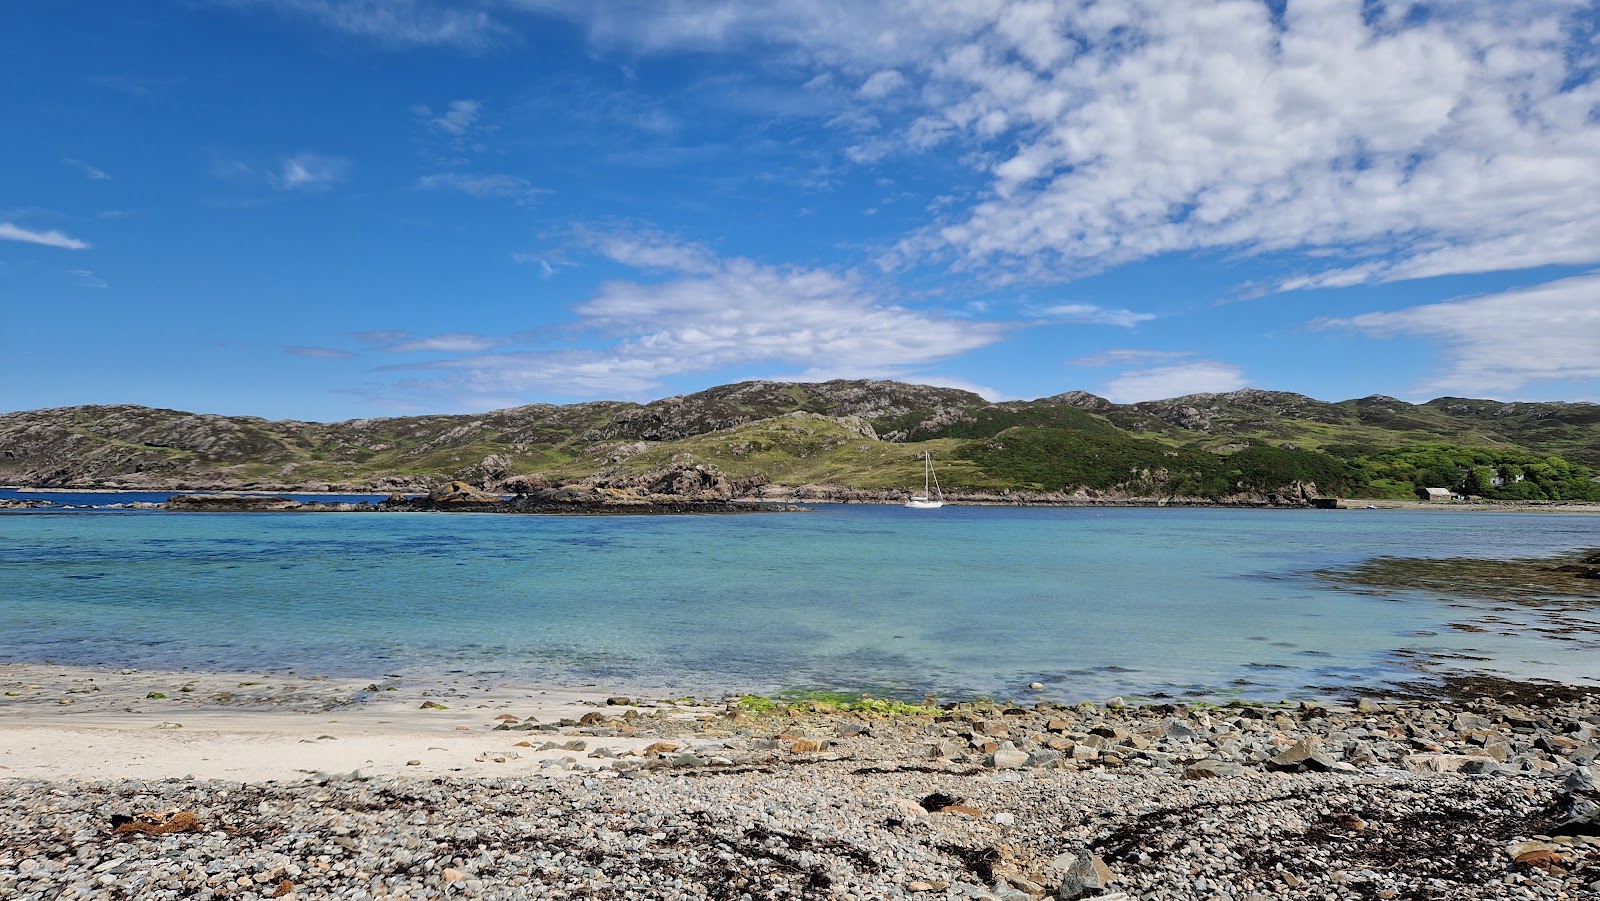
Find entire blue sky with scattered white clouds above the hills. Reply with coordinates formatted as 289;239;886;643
0;0;1600;419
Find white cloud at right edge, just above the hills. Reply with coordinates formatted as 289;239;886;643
1314;274;1600;395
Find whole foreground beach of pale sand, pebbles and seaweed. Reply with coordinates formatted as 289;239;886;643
0;664;1600;901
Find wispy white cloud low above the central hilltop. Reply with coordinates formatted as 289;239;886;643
390;234;1003;397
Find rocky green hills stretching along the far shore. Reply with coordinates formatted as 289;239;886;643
0;381;1600;503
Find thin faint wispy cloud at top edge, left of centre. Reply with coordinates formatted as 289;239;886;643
225;0;510;51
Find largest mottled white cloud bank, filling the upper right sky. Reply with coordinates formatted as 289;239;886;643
517;0;1600;286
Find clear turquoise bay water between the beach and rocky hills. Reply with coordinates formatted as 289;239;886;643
0;506;1600;699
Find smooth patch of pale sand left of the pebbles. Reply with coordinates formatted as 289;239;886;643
0;664;709;781
